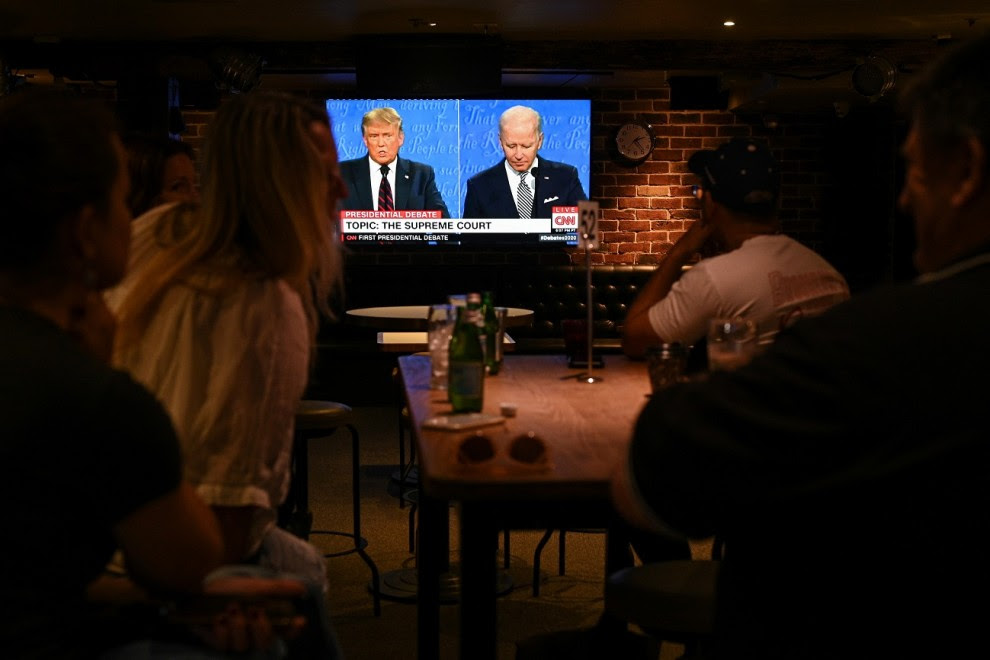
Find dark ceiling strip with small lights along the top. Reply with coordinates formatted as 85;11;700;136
0;0;990;41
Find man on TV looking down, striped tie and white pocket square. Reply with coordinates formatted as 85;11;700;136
464;105;587;218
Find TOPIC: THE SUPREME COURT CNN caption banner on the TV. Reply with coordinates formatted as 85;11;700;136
340;206;578;245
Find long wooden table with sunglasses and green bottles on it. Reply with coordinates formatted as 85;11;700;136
399;355;650;660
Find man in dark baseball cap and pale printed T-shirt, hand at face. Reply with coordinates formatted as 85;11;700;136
622;138;849;357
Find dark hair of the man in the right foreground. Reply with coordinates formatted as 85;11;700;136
900;34;990;151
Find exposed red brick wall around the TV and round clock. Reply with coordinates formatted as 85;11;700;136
182;86;829;264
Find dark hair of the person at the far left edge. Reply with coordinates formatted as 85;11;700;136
0;89;119;271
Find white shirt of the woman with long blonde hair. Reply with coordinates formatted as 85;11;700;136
108;206;310;553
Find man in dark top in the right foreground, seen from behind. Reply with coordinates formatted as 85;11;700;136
613;37;990;659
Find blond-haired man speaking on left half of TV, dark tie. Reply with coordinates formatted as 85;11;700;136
340;107;450;218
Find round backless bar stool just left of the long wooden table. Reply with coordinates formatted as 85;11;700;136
279;400;381;616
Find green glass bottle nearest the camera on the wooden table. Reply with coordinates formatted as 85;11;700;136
447;293;485;412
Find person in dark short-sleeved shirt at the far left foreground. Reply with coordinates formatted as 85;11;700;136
0;91;223;657
